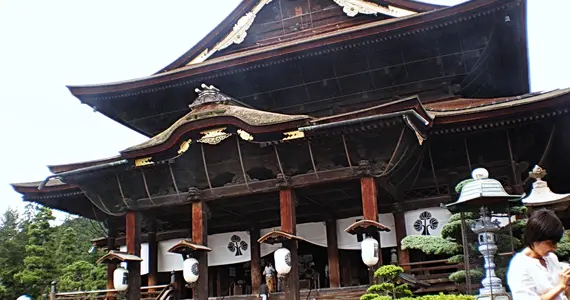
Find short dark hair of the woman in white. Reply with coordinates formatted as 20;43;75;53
524;209;564;249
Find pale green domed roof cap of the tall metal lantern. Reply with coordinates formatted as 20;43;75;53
446;168;524;211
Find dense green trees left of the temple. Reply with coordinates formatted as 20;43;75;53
0;205;106;299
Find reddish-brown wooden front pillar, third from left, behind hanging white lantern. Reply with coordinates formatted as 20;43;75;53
279;189;301;300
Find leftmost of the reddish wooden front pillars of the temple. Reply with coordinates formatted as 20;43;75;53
126;211;141;300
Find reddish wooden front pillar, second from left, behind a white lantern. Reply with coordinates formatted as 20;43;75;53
192;200;208;300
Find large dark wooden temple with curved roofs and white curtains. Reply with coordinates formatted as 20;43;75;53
13;0;570;300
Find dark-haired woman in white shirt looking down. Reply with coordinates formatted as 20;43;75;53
507;209;570;300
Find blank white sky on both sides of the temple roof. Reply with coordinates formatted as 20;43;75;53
0;0;570;220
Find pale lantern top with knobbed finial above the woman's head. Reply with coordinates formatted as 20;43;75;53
522;165;570;206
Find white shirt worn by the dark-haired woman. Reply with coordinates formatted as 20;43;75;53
507;252;568;300
